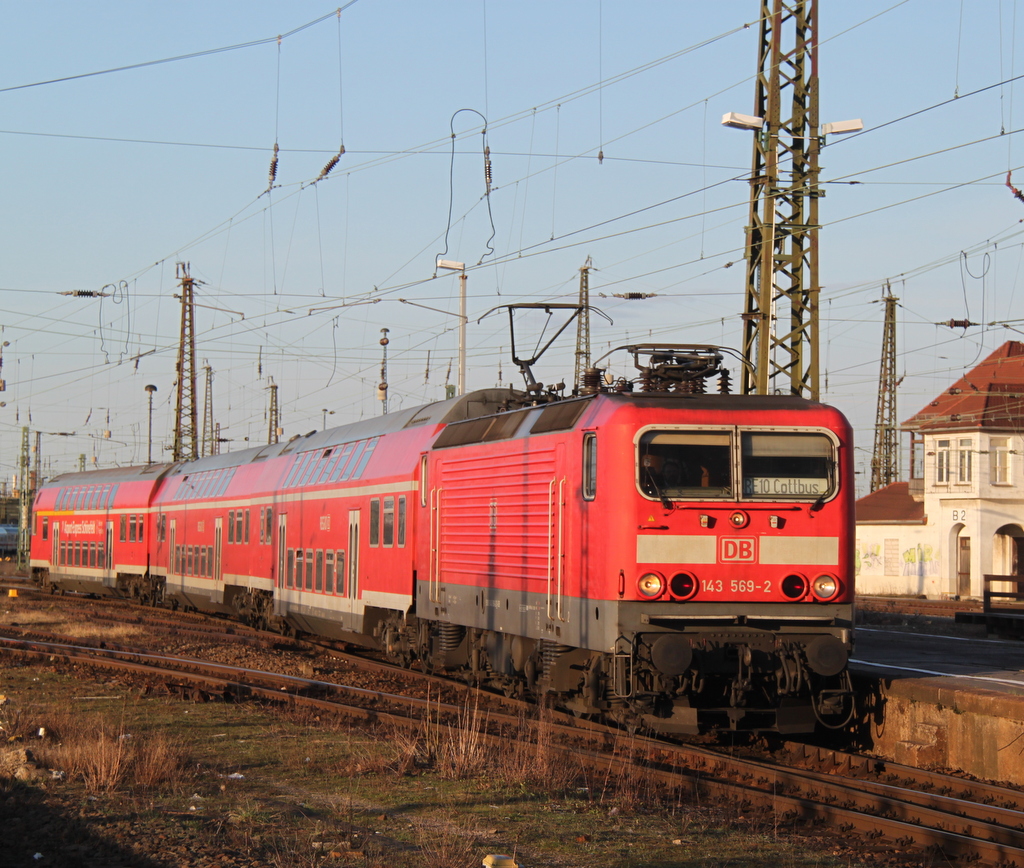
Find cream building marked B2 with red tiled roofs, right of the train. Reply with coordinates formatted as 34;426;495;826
856;341;1024;599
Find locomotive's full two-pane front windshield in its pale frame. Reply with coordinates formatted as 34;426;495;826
637;430;836;503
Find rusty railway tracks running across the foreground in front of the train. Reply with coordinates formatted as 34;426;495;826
0;610;1024;868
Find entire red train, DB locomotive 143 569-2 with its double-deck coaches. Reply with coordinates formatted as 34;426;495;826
32;345;854;733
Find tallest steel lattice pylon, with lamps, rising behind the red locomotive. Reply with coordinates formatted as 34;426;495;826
742;0;821;400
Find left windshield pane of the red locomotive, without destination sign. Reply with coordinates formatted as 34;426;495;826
637;431;733;501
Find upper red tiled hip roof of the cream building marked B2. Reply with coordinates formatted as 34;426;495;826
903;341;1024;431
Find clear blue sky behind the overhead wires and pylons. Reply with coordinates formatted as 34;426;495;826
0;0;1024;491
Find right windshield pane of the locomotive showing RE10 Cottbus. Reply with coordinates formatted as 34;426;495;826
741;431;836;501
